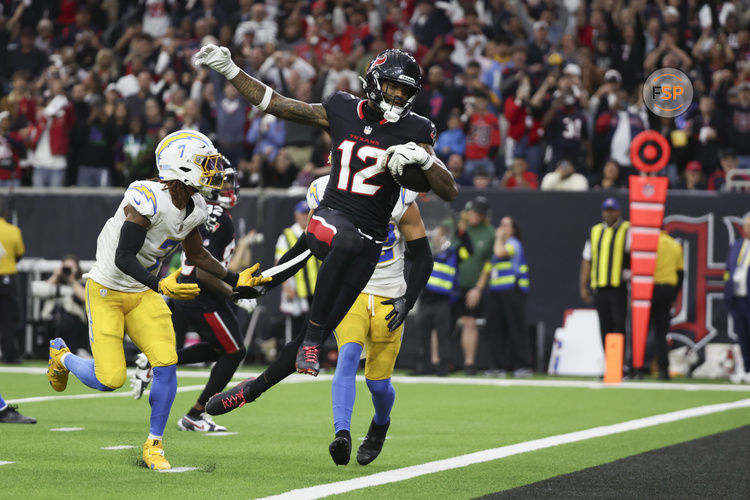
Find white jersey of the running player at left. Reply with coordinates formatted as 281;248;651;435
88;181;207;292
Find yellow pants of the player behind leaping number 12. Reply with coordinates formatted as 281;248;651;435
334;293;404;380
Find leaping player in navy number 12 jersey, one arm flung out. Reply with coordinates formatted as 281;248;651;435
195;44;457;376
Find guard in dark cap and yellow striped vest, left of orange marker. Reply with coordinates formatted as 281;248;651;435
579;198;630;345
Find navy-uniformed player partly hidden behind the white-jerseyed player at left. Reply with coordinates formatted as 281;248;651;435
131;169;246;432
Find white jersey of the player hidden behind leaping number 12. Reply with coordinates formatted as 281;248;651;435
307;176;419;298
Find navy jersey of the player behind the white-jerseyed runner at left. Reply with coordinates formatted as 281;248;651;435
177;203;234;309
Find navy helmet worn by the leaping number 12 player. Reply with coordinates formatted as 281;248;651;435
363;49;422;122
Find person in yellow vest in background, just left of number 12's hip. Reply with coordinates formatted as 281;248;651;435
276;200;320;342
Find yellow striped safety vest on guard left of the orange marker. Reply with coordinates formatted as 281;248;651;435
590;221;630;288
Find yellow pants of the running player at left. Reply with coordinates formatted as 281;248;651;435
86;279;177;389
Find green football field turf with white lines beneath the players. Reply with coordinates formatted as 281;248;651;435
0;364;750;499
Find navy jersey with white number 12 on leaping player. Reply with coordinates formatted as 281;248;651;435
323;92;437;241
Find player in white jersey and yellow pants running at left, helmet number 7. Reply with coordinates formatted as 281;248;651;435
47;130;268;470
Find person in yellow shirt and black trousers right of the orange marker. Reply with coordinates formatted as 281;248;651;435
651;231;685;380
